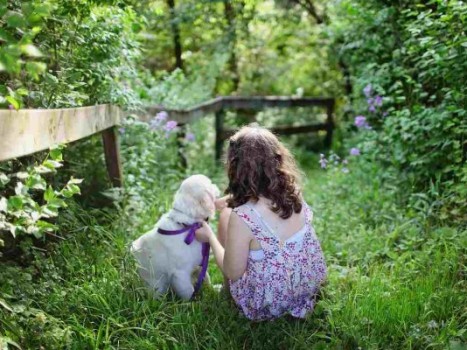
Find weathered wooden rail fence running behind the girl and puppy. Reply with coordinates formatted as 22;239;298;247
0;96;334;187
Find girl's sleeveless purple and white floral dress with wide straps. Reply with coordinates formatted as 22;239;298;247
230;202;327;320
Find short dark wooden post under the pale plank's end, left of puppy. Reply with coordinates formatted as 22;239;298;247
102;126;123;187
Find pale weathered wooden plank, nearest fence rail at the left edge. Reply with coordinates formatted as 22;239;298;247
0;105;122;161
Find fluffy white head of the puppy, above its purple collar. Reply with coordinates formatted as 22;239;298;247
174;175;220;221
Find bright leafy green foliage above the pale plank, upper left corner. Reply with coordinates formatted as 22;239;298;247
0;0;143;109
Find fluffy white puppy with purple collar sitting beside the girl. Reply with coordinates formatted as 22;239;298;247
131;175;219;299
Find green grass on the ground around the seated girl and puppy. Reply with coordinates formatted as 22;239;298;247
0;139;467;349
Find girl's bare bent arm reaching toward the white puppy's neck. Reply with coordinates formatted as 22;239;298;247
196;213;252;281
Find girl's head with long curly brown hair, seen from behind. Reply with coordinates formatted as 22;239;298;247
226;126;302;219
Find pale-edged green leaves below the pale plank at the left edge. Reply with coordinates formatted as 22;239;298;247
0;148;82;242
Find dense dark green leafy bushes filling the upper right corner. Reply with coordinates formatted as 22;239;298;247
331;0;467;218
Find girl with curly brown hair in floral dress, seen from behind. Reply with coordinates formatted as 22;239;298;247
196;126;326;320
